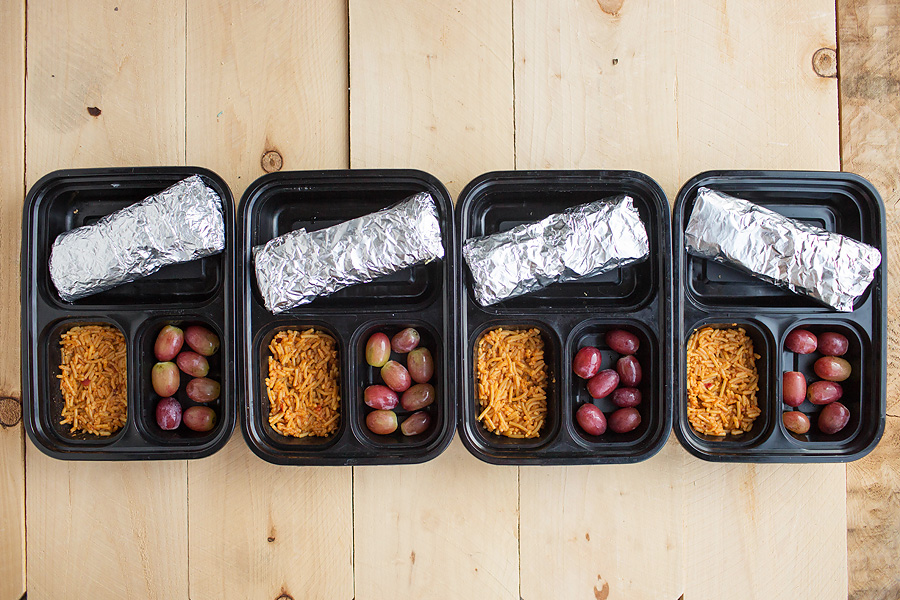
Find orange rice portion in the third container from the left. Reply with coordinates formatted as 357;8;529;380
477;327;547;438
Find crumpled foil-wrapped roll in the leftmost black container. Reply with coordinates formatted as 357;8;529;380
50;175;225;302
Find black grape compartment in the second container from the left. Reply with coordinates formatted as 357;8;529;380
349;319;447;449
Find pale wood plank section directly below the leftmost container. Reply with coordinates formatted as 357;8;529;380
26;458;188;600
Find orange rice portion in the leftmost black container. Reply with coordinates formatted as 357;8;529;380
57;325;128;437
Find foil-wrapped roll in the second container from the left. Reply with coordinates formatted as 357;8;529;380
253;192;444;314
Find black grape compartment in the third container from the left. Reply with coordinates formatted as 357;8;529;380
563;321;668;453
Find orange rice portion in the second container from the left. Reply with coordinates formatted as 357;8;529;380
266;329;341;438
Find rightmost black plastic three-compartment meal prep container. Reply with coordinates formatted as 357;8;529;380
673;171;887;462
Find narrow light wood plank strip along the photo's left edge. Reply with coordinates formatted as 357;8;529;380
0;2;25;599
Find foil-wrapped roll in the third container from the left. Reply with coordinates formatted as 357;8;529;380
463;196;650;306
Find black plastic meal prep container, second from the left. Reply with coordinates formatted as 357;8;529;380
239;169;457;465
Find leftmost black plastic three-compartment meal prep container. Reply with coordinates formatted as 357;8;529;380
21;167;235;460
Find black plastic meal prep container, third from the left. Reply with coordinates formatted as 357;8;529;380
456;171;672;465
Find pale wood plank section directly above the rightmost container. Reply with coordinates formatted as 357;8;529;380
675;0;840;182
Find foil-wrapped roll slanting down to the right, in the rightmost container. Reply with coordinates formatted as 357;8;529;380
684;187;881;312
